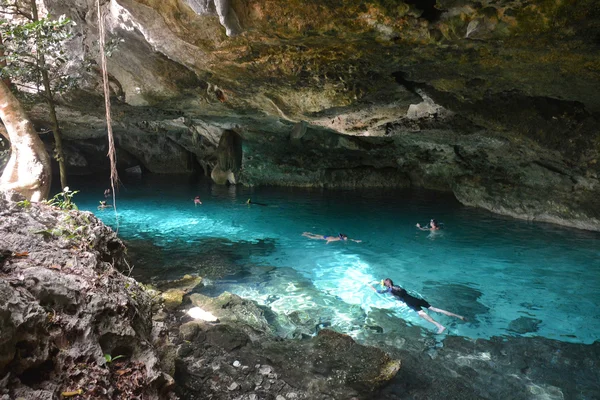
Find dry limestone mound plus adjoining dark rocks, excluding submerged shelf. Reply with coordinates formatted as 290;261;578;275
0;195;400;400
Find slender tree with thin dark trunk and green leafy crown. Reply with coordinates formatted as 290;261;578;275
0;0;74;189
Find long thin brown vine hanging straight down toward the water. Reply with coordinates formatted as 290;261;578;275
96;0;119;225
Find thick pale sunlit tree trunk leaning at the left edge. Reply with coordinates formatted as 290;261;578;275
0;81;52;201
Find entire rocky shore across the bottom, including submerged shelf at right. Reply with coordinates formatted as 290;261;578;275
0;199;600;400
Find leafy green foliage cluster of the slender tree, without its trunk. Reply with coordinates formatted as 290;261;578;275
0;10;76;92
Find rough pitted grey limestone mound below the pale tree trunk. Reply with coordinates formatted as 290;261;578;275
0;198;173;400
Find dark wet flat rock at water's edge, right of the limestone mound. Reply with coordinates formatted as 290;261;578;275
176;293;400;400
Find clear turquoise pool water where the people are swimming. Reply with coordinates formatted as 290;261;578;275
71;177;600;343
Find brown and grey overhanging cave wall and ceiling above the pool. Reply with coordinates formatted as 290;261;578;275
11;0;600;230
